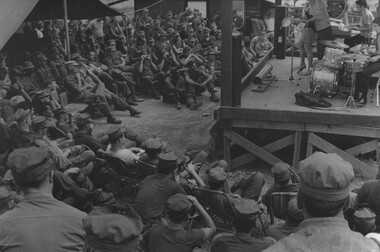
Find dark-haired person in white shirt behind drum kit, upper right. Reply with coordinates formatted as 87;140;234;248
344;0;374;51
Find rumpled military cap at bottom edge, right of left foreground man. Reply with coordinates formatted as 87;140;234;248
83;204;143;252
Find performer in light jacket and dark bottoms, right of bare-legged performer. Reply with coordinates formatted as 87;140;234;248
307;0;332;60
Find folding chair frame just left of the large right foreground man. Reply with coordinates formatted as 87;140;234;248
269;192;297;224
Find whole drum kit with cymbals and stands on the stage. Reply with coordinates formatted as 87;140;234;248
310;40;370;108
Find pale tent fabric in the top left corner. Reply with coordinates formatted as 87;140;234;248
0;0;38;49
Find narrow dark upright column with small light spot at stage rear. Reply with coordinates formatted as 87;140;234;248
274;5;287;59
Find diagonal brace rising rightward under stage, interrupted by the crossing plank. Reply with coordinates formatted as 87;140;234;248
231;134;295;170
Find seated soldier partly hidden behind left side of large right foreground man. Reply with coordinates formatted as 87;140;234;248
267;198;303;241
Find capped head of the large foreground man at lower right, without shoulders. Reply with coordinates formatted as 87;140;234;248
298;152;355;217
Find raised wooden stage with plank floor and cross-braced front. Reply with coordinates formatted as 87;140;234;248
215;58;380;178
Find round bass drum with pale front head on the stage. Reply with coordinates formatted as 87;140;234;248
309;63;339;97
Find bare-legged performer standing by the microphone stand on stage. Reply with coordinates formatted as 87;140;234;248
296;0;317;75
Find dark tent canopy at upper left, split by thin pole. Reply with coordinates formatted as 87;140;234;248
26;0;121;21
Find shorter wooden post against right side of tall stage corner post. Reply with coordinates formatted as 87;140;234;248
232;32;242;107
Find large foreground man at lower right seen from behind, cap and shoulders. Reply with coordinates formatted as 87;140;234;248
264;152;379;252
